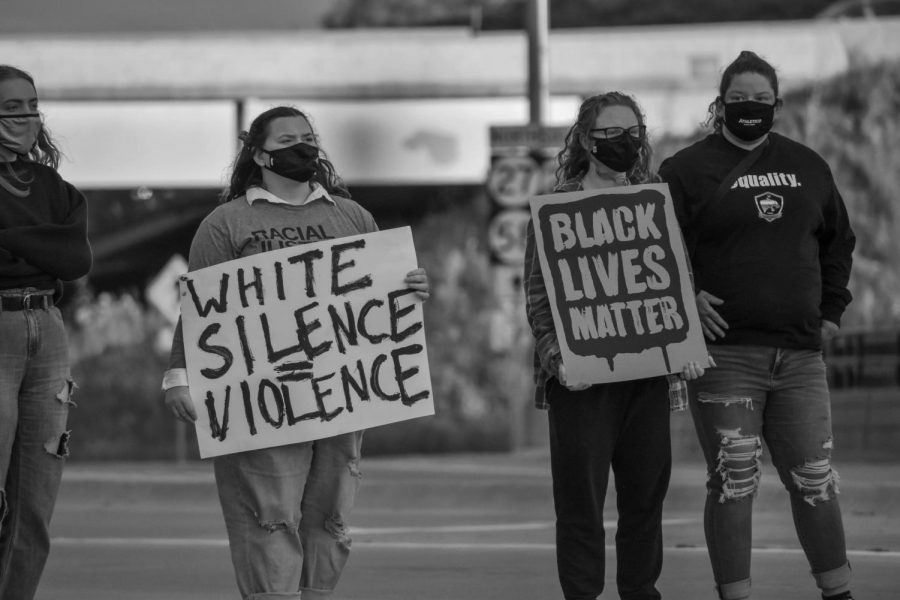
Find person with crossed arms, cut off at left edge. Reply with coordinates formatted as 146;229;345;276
0;65;91;600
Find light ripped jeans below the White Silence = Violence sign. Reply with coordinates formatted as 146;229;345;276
215;431;363;600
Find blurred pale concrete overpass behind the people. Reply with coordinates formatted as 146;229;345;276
0;17;900;188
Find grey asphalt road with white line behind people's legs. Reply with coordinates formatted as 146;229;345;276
38;451;900;600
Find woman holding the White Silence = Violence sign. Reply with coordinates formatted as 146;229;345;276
163;107;429;600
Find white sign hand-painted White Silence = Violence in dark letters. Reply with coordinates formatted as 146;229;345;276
179;227;434;458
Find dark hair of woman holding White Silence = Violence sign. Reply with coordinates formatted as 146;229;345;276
221;106;350;202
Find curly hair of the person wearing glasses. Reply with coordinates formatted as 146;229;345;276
556;92;653;184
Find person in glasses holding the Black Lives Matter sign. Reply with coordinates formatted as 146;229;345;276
524;92;703;600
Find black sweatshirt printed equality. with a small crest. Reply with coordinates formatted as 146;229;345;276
659;133;856;349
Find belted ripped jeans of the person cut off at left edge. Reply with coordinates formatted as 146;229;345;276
0;308;72;600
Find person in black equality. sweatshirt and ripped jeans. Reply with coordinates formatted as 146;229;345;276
660;51;855;600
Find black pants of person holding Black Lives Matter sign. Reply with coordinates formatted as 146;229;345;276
547;377;672;600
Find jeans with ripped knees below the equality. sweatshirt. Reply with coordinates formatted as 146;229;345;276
689;345;850;600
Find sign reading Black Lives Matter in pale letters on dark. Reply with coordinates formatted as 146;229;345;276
531;183;709;383
